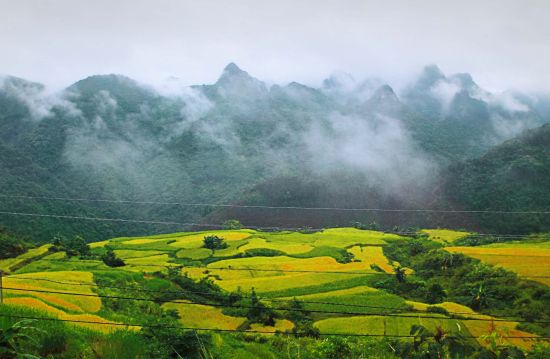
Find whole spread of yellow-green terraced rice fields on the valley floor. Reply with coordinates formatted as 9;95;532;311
0;228;550;347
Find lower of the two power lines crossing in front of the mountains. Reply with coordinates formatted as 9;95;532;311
0;194;550;214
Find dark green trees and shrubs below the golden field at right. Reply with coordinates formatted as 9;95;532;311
380;239;550;336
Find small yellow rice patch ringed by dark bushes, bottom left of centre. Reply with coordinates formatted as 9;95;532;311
162;303;246;330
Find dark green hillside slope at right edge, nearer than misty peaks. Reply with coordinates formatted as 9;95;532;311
444;125;550;233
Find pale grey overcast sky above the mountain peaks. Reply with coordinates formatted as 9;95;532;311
0;0;550;90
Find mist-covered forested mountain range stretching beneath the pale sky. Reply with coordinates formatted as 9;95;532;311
0;63;550;242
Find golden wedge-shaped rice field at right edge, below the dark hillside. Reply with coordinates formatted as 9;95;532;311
445;242;550;285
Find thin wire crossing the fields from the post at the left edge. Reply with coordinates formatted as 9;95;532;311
4;287;550;324
